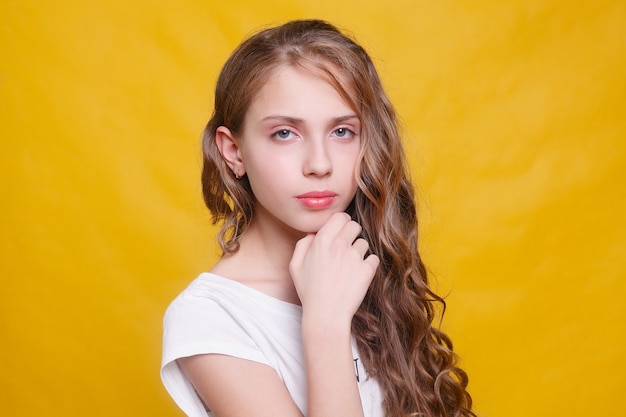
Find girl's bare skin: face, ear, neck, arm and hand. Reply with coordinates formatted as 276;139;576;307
179;66;379;417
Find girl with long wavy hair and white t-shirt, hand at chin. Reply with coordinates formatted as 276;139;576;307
161;20;474;417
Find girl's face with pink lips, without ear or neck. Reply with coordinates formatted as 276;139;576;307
232;66;361;233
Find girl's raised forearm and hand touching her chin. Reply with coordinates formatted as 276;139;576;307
290;213;379;417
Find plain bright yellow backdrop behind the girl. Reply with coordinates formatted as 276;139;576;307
0;0;626;417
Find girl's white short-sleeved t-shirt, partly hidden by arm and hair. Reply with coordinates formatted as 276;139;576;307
161;273;383;417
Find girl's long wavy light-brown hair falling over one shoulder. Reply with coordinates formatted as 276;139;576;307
202;20;475;417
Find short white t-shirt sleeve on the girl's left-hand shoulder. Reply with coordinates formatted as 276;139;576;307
161;293;269;417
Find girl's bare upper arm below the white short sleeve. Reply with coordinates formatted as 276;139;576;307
177;354;302;417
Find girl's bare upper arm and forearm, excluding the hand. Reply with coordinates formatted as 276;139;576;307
177;320;363;417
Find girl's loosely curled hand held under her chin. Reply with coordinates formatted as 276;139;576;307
289;212;380;325
